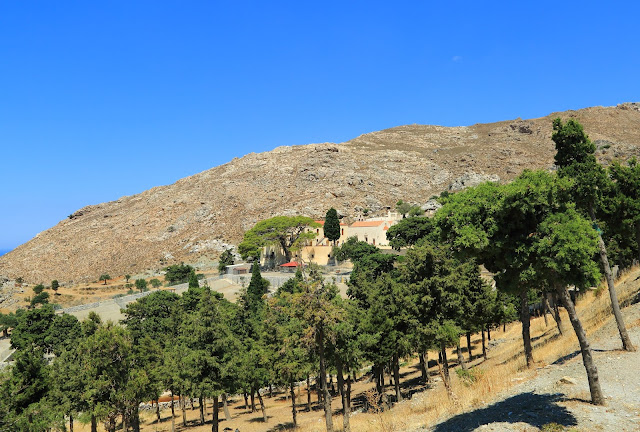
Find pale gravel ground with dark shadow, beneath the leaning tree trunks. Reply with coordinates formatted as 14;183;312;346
429;303;640;432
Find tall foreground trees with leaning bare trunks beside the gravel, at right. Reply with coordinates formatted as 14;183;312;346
428;119;640;404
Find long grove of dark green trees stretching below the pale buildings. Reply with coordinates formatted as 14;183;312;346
0;239;506;431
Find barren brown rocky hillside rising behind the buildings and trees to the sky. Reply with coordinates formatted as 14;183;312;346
0;104;640;282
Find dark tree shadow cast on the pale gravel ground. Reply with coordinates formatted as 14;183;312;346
432;393;578;432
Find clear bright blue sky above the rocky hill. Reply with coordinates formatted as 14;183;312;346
0;0;640;250
